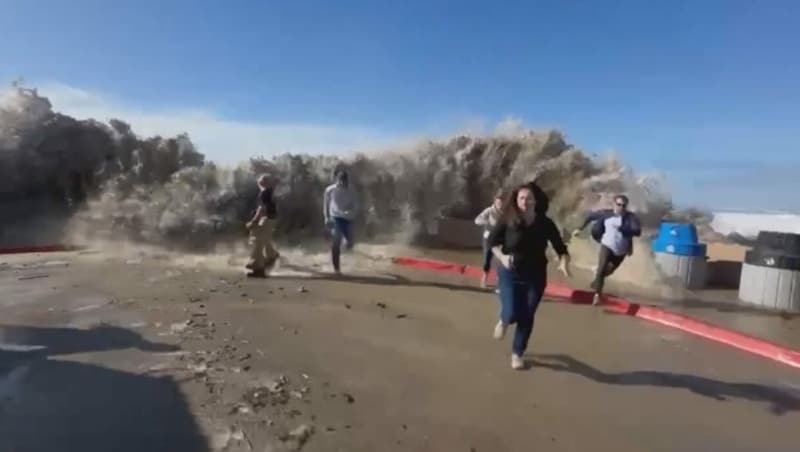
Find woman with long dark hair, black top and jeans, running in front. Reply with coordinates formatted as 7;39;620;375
489;185;569;369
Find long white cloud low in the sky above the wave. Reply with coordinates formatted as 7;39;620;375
38;83;401;163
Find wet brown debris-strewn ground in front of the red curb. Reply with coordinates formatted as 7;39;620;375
0;247;800;452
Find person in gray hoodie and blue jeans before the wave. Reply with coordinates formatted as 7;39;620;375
322;171;358;275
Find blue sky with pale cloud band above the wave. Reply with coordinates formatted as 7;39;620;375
0;0;800;210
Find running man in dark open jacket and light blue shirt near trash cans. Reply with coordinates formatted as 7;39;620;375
573;195;642;306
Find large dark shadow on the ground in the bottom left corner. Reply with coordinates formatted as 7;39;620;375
0;325;209;452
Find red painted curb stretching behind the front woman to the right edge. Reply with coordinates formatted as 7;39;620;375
392;257;800;369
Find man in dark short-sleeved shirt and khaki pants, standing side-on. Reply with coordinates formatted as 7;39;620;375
246;175;280;278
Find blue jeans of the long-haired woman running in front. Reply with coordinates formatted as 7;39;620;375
497;265;547;356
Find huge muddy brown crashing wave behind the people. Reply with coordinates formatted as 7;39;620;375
0;86;672;249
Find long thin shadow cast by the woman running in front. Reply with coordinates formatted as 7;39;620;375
529;354;800;416
